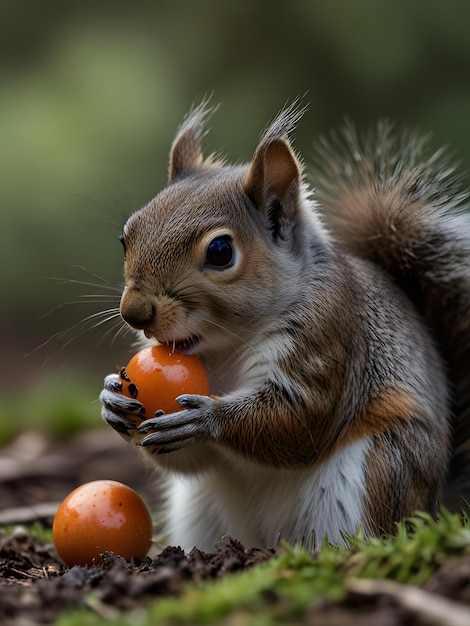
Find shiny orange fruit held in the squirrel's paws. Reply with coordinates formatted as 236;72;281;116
121;345;209;418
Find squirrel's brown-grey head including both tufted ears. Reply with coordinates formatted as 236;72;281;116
121;103;323;354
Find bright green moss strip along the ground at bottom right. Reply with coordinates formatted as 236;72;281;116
58;511;470;626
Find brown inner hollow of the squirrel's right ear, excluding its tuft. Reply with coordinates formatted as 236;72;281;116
244;137;301;218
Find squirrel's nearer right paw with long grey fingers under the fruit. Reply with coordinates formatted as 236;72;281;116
138;394;216;454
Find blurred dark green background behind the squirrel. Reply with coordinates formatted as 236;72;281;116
0;0;470;436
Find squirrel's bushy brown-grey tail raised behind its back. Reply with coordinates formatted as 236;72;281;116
313;123;470;509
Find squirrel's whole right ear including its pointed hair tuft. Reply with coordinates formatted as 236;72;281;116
244;103;303;238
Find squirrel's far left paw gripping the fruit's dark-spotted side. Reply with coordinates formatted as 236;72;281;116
99;374;145;440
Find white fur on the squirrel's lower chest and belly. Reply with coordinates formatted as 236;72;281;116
164;439;371;550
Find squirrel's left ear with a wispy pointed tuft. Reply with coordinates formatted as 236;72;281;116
168;100;213;182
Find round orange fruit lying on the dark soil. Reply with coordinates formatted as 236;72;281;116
52;480;153;567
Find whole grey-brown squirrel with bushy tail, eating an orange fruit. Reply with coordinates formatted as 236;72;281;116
100;102;470;550
